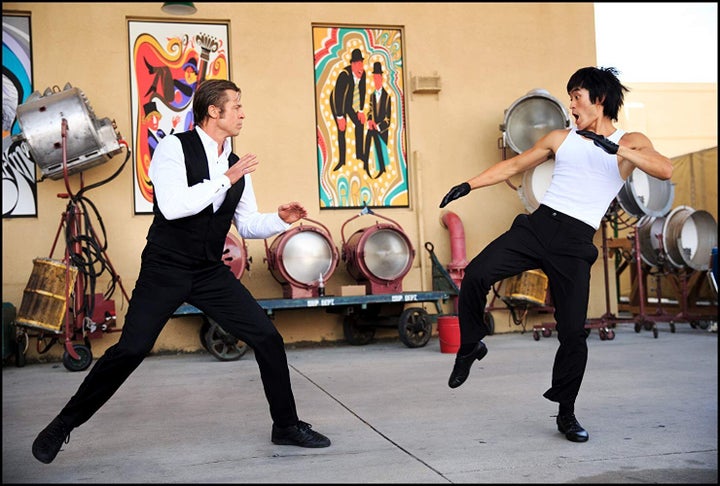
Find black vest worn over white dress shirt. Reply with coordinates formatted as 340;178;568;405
147;130;245;261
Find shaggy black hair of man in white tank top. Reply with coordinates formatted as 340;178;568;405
567;66;630;121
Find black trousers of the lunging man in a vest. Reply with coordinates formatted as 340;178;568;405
60;243;298;427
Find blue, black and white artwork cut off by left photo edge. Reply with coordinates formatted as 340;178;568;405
2;12;38;218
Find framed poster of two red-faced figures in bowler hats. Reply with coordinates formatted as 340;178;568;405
312;25;409;209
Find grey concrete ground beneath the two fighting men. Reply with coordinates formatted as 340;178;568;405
2;323;718;484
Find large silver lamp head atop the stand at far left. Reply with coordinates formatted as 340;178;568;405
17;83;122;180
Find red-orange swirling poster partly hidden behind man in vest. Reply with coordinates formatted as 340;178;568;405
128;20;230;214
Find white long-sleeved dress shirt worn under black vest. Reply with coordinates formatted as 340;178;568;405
148;127;290;239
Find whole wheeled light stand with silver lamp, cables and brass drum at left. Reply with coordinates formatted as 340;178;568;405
16;83;130;371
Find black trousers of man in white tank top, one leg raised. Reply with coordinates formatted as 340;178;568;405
458;205;598;403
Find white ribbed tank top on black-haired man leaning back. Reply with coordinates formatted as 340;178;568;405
540;128;625;229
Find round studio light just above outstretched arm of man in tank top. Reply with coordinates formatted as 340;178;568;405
500;89;570;154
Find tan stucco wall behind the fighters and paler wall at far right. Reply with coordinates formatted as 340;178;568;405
3;2;717;359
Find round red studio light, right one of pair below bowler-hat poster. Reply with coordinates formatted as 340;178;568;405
341;208;415;295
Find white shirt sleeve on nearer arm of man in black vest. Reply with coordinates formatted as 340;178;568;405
148;135;231;220
